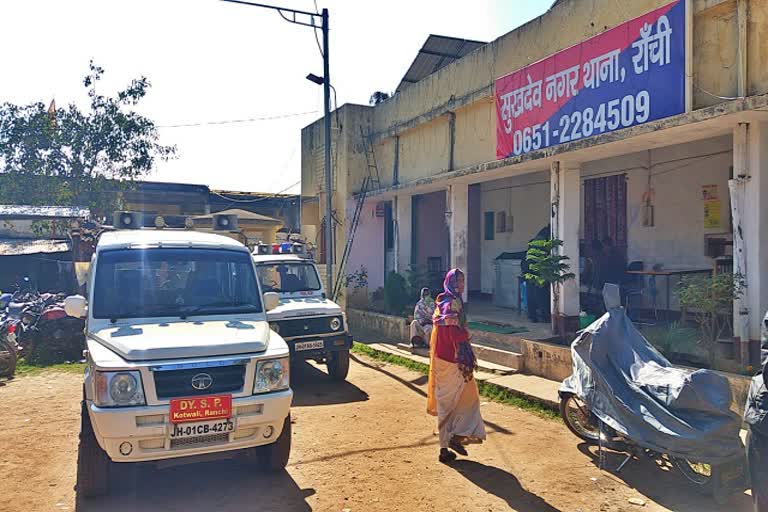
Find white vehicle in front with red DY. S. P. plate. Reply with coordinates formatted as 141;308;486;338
65;229;293;497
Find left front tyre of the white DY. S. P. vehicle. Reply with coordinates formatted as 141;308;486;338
76;400;112;498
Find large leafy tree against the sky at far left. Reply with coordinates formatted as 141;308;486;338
0;61;176;215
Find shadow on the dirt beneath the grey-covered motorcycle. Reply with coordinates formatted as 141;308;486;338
578;443;752;512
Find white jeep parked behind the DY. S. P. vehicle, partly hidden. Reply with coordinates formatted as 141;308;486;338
253;244;352;381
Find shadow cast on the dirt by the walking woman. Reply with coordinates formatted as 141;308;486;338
450;459;560;512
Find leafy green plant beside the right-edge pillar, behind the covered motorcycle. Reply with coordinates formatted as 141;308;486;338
677;272;744;368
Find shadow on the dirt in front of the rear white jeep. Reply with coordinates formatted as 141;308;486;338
291;361;368;407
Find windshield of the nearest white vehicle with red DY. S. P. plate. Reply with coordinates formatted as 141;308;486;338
93;248;262;319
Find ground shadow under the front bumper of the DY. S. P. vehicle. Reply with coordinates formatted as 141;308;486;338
77;460;315;512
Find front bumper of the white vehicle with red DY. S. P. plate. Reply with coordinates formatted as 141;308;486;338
87;389;293;462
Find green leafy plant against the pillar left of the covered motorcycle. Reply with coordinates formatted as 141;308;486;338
523;239;576;336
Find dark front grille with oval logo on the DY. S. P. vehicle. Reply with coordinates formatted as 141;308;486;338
154;364;245;399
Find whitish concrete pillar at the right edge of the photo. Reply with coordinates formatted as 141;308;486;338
733;122;768;355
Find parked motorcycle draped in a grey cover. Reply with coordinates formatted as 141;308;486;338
559;289;748;504
